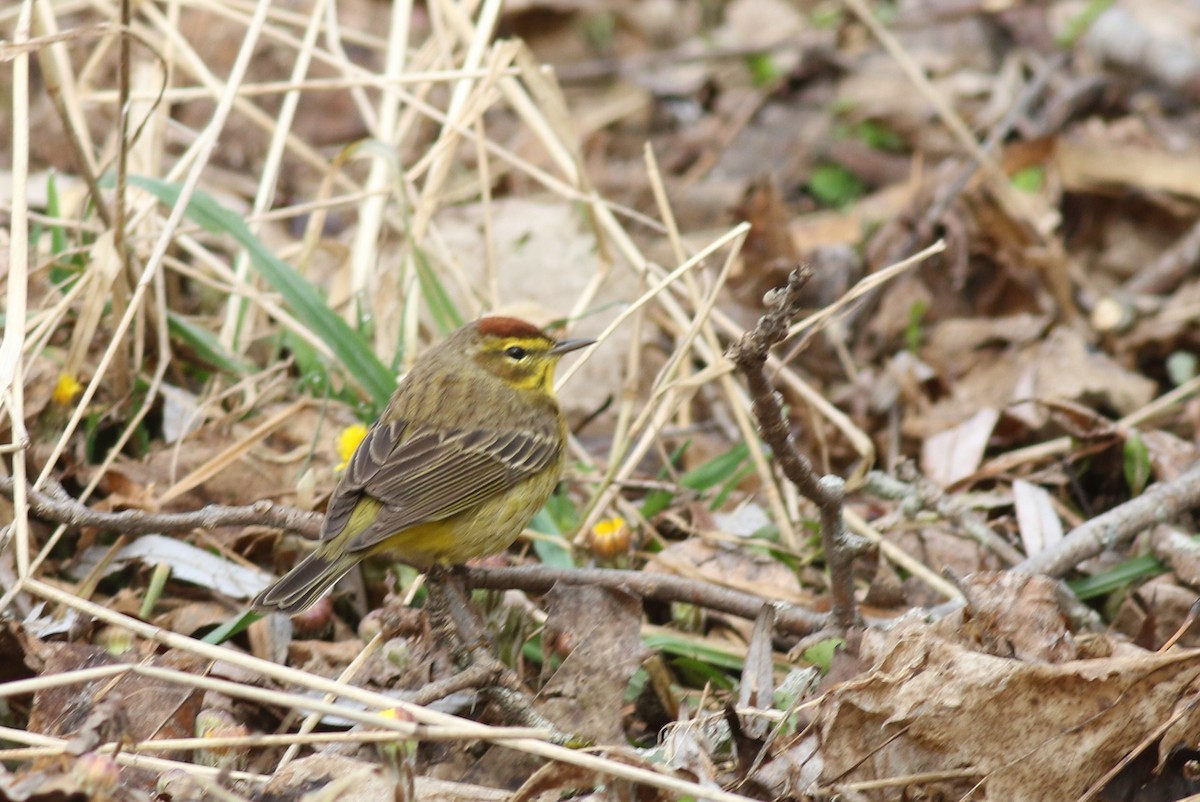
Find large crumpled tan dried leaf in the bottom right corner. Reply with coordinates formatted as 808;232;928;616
818;629;1200;800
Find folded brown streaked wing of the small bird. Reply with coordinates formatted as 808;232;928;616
323;421;562;551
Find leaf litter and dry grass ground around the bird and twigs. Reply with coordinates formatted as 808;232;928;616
0;0;1200;802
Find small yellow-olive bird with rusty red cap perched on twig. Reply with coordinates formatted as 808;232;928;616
254;317;594;614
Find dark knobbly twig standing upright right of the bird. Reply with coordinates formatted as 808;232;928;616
728;267;864;629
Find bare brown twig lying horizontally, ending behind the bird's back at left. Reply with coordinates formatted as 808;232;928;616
0;477;324;538
